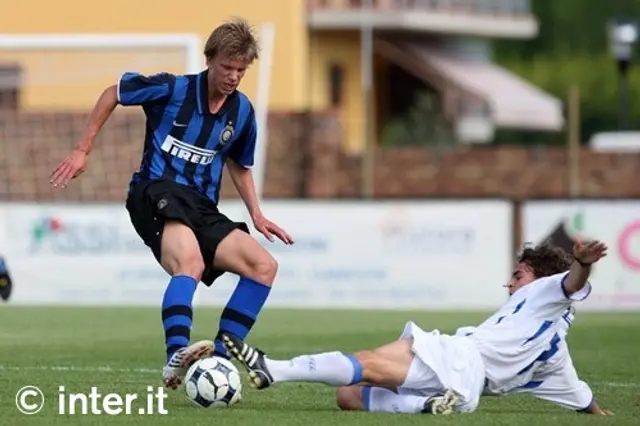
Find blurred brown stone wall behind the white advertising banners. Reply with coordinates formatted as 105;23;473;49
0;110;640;201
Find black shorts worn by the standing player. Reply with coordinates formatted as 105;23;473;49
126;179;249;286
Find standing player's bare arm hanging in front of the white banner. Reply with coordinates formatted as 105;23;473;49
227;161;293;244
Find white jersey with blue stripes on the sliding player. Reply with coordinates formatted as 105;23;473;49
469;272;591;394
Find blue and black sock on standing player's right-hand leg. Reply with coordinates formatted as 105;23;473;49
215;277;271;356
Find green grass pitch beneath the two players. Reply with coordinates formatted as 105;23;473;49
0;306;640;426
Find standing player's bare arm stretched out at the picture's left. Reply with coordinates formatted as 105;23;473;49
50;85;118;187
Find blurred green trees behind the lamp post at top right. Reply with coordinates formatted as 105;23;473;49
495;0;640;143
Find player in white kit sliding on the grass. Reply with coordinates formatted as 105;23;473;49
223;241;607;414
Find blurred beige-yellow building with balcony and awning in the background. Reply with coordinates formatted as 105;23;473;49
0;0;563;152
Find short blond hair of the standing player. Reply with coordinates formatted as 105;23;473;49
204;17;259;64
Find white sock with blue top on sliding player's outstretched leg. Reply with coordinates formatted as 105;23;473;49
265;352;362;386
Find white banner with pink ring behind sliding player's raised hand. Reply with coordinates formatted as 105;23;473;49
522;200;640;310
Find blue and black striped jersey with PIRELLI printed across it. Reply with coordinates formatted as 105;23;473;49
118;71;257;203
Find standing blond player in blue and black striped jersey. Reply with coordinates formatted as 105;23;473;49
51;19;293;389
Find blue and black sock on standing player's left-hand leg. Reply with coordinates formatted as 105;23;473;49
162;275;198;361
